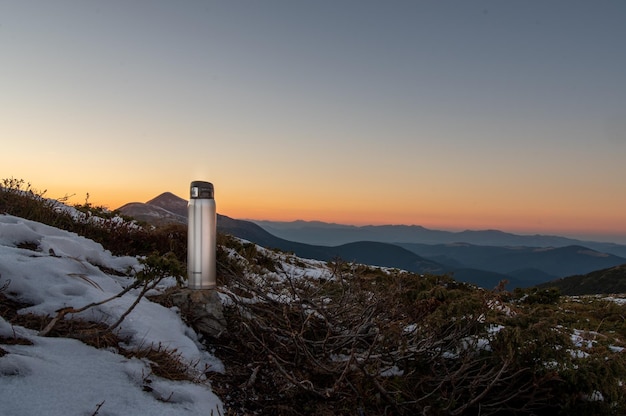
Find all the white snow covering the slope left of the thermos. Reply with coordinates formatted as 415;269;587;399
0;215;224;416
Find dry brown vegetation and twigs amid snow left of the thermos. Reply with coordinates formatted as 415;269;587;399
0;179;198;389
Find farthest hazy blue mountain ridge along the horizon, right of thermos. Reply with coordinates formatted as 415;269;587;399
253;220;626;258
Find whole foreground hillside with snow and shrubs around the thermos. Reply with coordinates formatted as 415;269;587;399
0;186;626;416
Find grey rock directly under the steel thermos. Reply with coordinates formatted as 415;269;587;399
172;289;226;338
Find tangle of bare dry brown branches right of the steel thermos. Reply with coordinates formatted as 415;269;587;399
216;254;580;415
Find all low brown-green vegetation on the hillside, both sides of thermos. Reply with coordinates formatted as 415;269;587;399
0;180;626;415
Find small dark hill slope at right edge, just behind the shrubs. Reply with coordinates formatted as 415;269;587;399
537;263;626;296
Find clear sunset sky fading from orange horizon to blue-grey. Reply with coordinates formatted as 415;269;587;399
0;0;626;243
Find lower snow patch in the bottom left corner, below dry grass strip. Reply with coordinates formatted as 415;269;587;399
0;329;219;416
